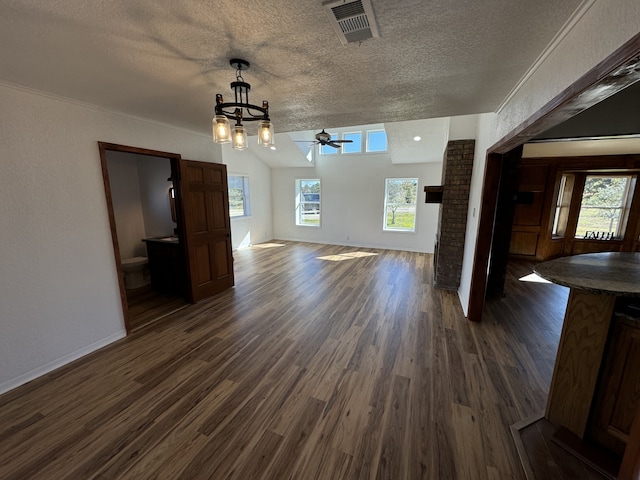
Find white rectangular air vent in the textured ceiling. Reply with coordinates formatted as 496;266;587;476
322;0;380;45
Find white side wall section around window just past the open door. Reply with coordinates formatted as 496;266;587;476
222;144;273;250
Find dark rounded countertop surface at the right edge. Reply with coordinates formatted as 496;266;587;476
533;252;640;297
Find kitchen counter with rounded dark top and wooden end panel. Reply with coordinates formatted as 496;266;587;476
534;252;640;446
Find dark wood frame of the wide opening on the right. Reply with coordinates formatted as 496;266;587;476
467;33;640;322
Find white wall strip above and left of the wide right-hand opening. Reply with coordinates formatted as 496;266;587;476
458;0;640;314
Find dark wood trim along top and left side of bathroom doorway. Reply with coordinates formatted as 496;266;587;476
98;142;180;333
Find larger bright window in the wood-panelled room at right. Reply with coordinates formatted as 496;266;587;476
575;175;632;240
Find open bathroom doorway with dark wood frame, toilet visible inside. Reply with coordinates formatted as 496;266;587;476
98;142;190;333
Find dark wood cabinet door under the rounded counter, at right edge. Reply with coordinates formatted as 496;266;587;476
589;317;640;456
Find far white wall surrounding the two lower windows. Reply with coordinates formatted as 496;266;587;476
272;154;442;252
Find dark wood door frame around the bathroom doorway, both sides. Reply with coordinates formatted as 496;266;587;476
98;142;186;334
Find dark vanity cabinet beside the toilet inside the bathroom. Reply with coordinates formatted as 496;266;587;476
144;237;187;295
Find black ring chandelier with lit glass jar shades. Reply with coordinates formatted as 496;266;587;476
213;58;274;150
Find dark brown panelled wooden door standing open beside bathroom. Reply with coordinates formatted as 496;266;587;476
179;159;234;302
